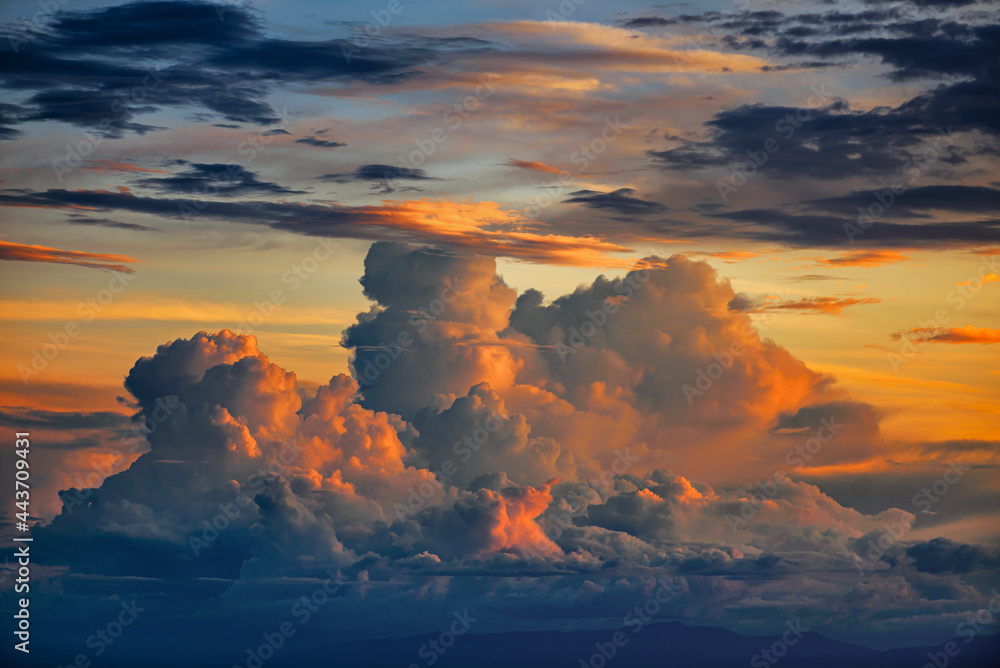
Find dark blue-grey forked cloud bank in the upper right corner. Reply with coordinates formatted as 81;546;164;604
625;8;1000;190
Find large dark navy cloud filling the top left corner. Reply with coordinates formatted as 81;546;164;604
0;0;481;138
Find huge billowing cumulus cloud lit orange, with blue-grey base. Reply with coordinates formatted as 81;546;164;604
21;243;989;656
